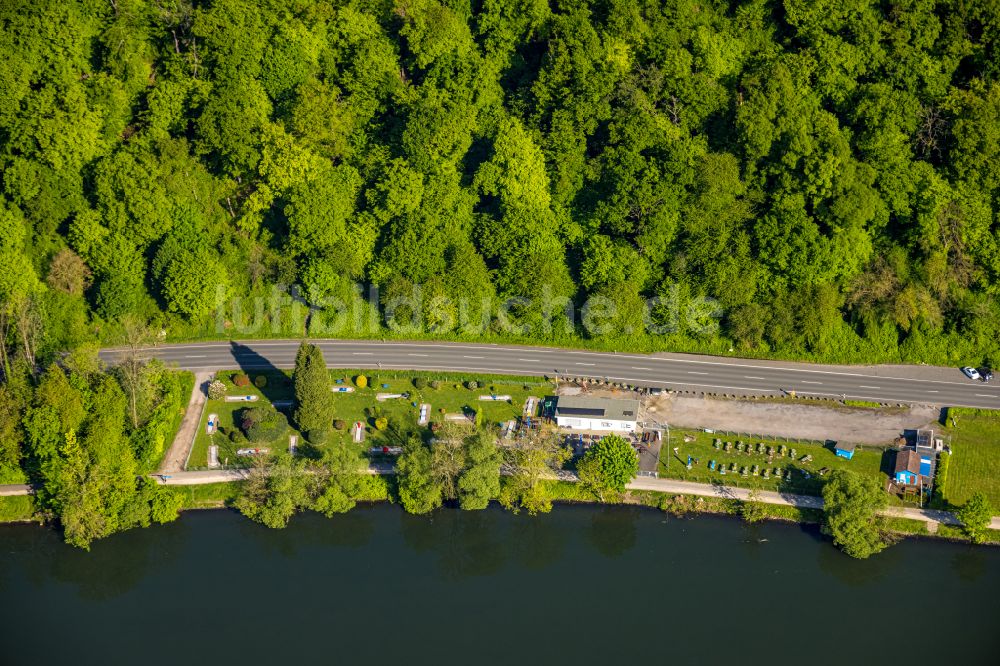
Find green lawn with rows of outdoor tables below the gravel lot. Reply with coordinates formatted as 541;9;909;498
660;429;886;495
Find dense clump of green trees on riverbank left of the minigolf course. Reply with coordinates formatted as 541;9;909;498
0;354;192;548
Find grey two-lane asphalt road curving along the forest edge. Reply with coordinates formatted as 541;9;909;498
101;340;1000;409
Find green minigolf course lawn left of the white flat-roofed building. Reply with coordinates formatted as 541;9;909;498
188;369;552;469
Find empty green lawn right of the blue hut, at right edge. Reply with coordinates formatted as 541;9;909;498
941;409;1000;506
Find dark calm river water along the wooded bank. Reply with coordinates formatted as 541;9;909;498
0;505;1000;666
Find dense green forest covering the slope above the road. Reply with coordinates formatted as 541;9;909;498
0;0;1000;374
